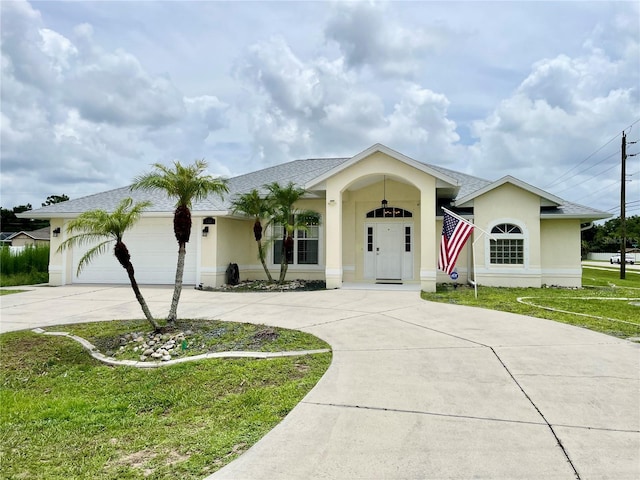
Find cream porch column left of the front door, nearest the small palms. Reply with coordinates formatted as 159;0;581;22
324;185;342;289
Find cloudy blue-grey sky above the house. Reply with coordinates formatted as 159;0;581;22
0;0;640;216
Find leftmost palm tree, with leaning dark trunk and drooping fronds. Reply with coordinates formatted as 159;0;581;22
58;198;160;331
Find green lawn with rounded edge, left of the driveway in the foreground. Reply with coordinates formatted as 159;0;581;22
0;321;331;479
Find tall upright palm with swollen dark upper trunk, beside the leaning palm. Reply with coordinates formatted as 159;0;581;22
131;160;229;323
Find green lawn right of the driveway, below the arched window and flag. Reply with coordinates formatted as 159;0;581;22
422;264;640;338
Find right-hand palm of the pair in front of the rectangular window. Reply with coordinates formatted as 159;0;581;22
265;182;319;283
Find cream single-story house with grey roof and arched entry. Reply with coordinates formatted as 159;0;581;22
20;144;611;291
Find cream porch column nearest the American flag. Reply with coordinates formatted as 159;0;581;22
420;186;438;292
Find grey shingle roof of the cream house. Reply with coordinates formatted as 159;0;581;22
21;152;610;219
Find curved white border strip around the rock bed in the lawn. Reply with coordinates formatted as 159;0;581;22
31;328;331;368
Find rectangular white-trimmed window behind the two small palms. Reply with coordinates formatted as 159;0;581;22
272;217;320;265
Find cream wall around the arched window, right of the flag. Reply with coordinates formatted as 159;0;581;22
474;184;544;288
